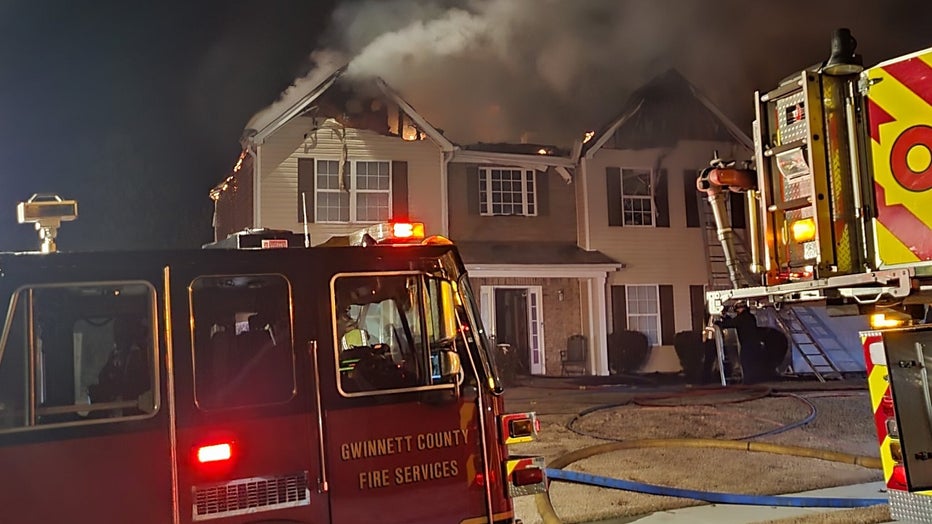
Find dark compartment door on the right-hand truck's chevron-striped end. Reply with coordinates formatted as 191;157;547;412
883;326;932;491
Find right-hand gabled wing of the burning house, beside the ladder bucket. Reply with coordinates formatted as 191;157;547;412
575;70;753;371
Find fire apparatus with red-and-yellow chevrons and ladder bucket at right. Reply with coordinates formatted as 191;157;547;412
697;29;932;522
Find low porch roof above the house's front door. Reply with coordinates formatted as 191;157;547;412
456;241;621;266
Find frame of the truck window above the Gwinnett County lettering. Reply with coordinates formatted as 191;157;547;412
330;271;458;398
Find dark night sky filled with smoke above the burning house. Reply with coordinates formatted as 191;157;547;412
0;0;932;254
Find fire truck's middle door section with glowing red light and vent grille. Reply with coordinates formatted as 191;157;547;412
171;268;329;522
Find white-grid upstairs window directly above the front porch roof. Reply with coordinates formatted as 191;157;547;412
479;167;537;216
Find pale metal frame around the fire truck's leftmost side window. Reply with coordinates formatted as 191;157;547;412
0;279;162;434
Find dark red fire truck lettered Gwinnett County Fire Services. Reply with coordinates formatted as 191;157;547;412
0;193;546;524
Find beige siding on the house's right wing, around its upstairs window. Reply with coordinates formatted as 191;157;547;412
582;142;748;331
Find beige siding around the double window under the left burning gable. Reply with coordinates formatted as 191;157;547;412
259;117;443;244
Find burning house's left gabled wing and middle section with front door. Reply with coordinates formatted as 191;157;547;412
211;69;620;374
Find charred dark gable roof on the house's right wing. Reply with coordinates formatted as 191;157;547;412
581;69;754;158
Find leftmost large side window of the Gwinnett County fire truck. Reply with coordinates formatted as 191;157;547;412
0;282;159;431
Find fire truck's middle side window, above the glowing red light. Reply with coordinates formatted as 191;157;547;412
190;275;295;410
